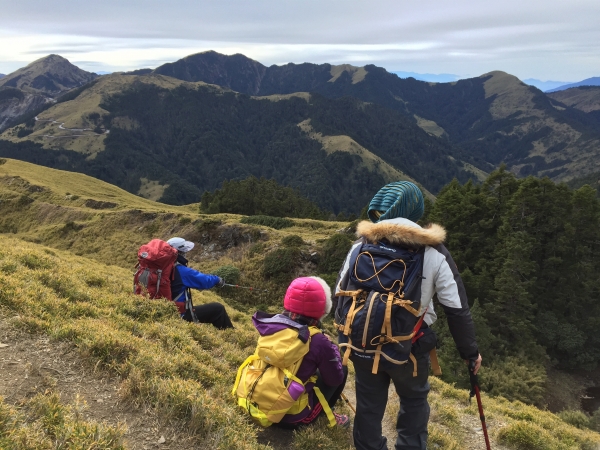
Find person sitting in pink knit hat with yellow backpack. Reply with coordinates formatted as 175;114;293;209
232;277;350;429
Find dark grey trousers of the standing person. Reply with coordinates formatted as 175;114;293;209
352;354;429;450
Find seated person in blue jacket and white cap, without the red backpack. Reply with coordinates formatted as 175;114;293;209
167;237;233;329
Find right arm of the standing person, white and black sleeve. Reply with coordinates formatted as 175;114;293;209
434;244;479;359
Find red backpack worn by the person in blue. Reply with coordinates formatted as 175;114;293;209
133;239;177;300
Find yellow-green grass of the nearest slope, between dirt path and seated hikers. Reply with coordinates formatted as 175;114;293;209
0;236;600;450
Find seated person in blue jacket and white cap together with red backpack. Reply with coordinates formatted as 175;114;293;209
133;237;233;329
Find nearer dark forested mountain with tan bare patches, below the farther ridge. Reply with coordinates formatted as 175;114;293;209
0;75;469;214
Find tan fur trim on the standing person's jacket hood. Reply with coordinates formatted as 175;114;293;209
356;219;446;247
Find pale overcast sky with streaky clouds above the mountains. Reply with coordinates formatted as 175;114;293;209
0;0;600;81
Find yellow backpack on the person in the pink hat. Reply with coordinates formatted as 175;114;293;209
231;327;336;427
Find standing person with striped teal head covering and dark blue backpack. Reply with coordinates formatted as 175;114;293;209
335;181;481;450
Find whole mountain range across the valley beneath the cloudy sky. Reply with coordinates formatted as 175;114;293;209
0;51;600;208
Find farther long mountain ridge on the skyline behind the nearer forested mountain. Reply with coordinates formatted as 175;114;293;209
155;52;600;185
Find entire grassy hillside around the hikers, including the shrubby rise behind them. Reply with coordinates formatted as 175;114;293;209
0;157;600;450
